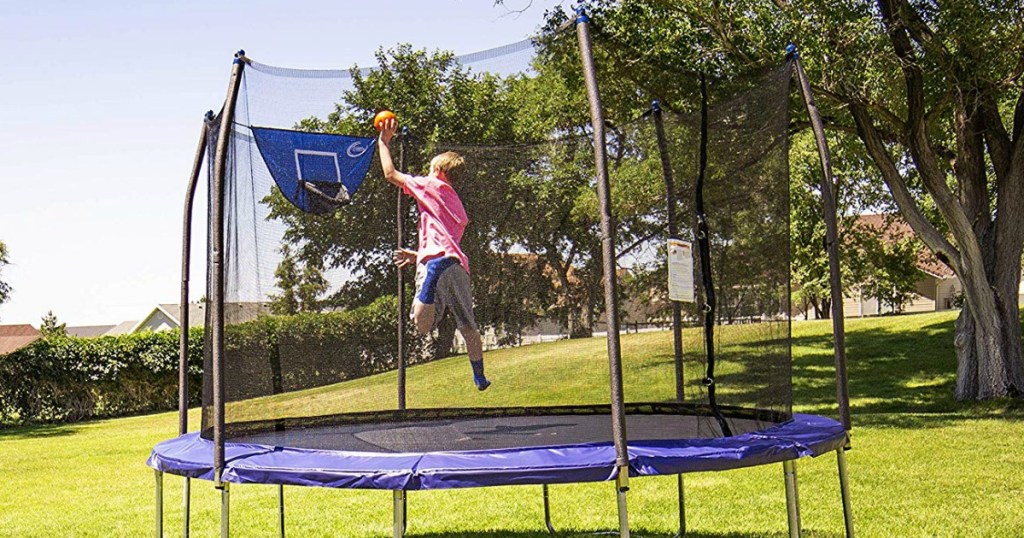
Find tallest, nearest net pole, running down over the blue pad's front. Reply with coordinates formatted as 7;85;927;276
575;12;630;538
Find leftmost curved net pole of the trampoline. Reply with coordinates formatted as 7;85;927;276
178;112;213;436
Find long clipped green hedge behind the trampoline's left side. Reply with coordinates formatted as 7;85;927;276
0;296;423;424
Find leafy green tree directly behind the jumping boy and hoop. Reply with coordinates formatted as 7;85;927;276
264;45;557;355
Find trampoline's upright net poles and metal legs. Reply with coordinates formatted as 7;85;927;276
154;7;854;538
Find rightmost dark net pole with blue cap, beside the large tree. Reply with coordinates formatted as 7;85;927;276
786;45;853;431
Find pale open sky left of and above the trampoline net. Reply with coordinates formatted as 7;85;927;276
0;0;571;327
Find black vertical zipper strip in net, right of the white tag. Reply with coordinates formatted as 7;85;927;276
693;73;732;437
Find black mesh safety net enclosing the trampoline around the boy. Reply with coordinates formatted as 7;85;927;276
197;27;791;451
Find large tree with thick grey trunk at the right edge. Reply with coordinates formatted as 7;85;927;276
561;0;1024;400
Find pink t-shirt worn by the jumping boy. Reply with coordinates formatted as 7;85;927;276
404;176;469;273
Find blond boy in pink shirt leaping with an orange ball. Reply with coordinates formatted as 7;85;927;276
377;119;490;390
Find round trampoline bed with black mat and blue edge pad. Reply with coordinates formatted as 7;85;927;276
146;414;847;491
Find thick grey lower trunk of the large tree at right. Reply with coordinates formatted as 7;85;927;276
953;277;1024;401
